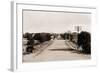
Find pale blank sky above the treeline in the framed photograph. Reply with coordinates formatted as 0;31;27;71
23;11;91;33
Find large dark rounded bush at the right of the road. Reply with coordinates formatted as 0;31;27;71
78;31;91;53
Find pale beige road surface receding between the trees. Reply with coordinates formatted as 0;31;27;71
23;40;90;62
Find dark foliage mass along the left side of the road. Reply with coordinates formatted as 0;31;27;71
23;33;51;53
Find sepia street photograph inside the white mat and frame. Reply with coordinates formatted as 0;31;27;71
22;9;91;63
